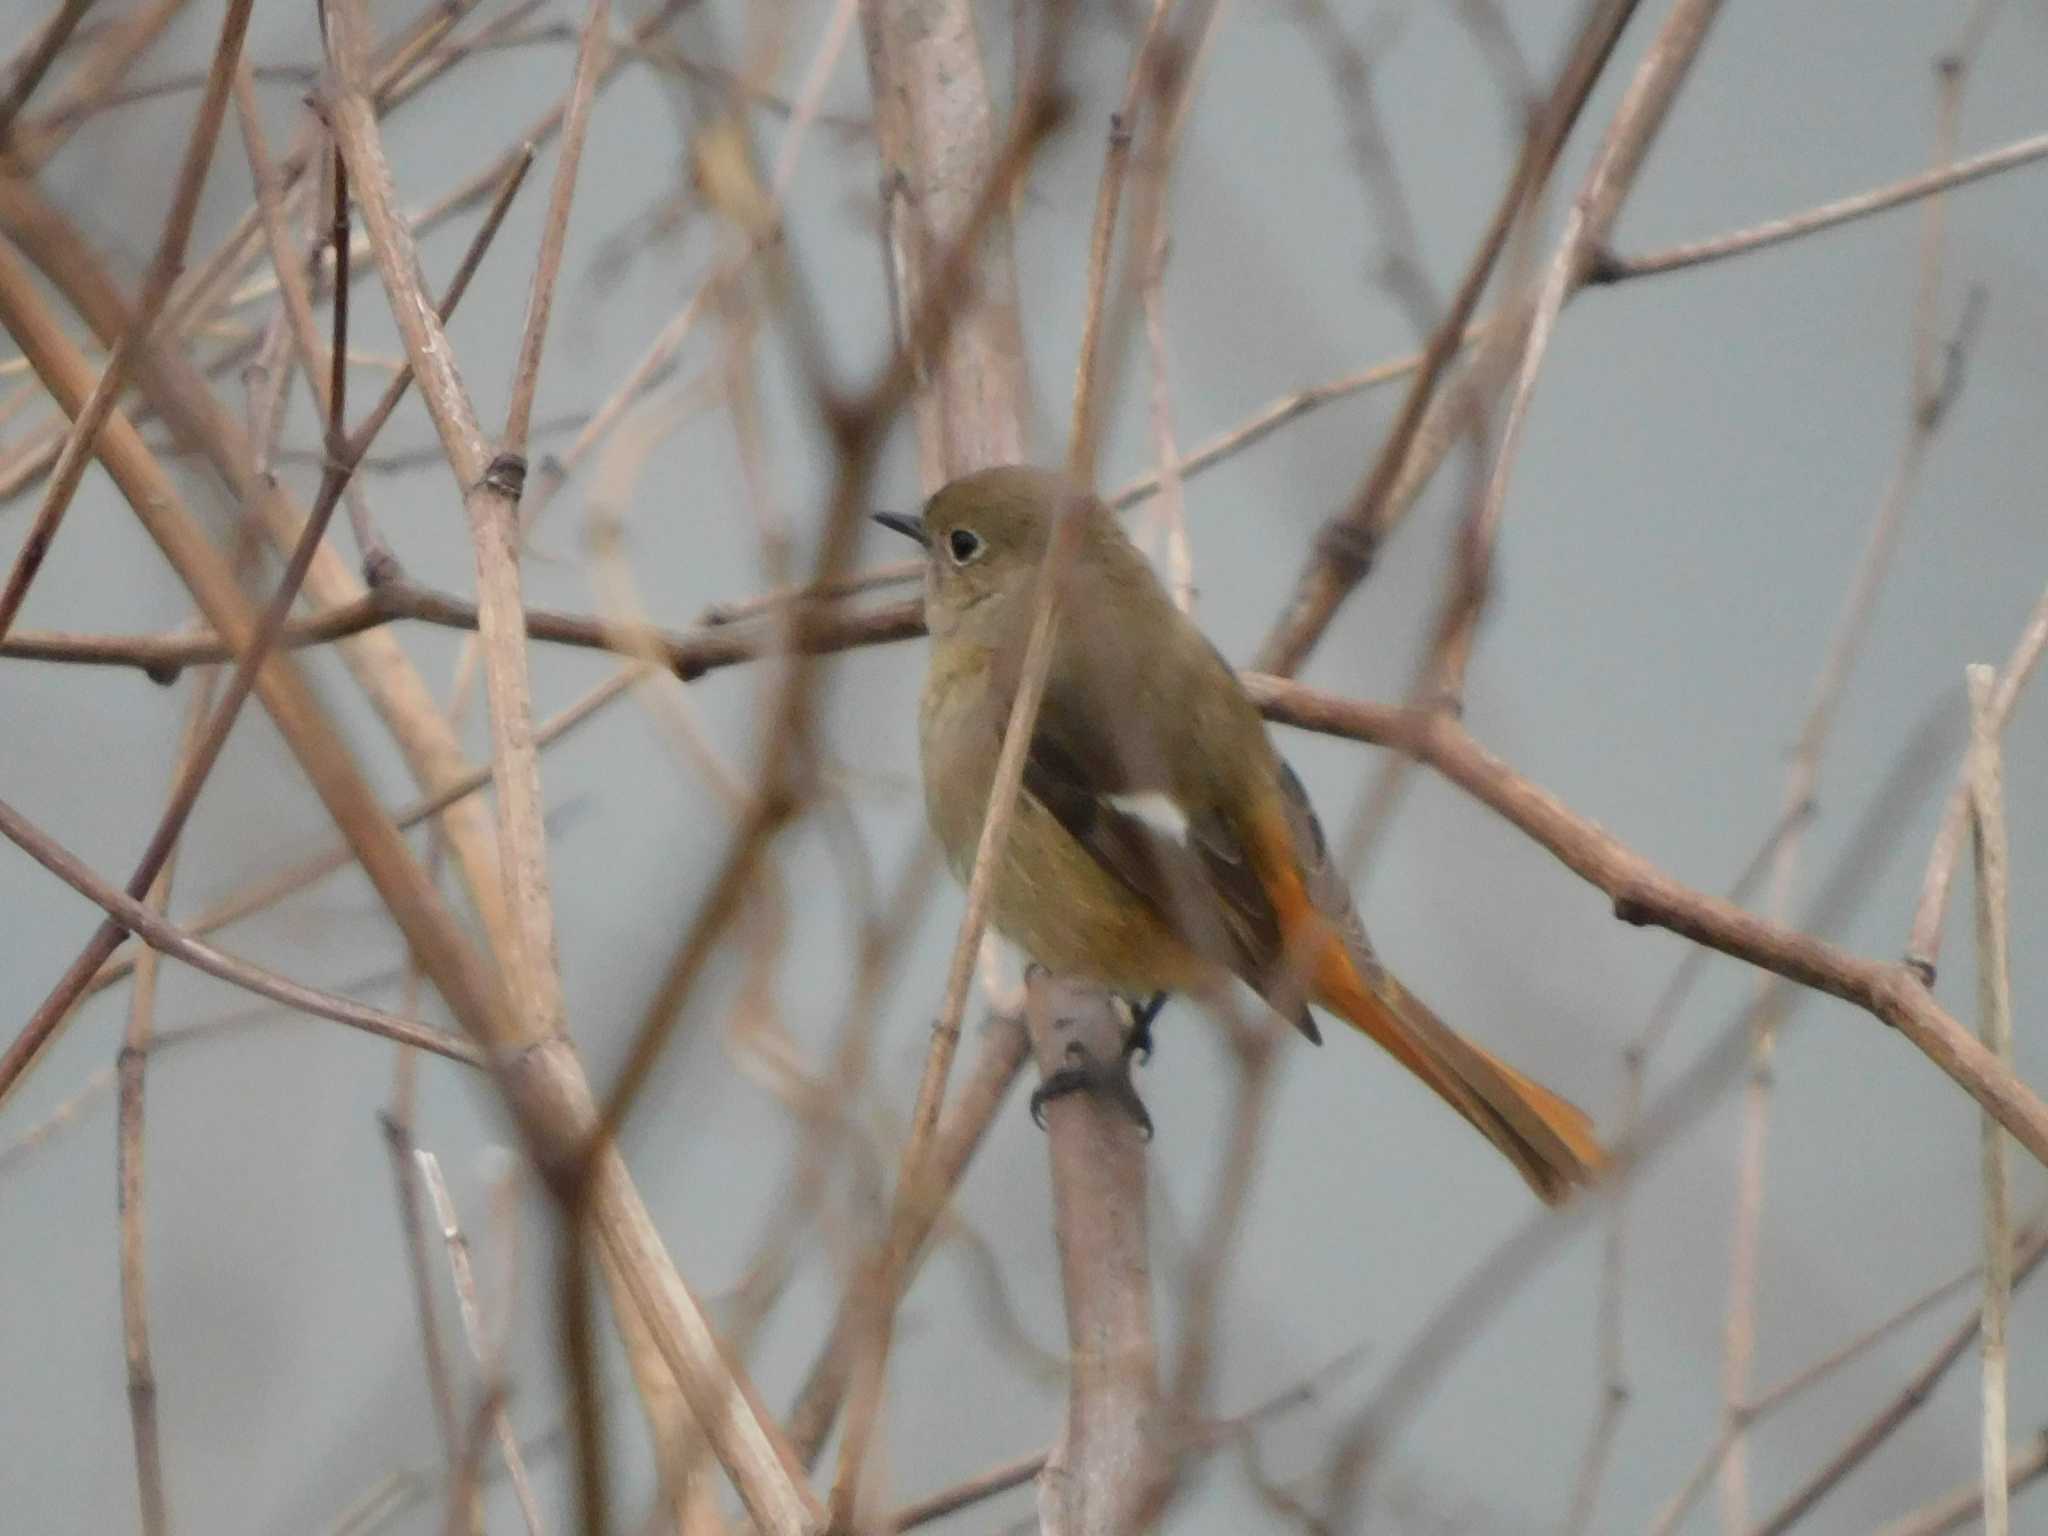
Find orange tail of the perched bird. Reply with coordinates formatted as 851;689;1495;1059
1313;938;1608;1204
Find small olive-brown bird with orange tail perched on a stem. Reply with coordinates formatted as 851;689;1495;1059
877;467;1604;1202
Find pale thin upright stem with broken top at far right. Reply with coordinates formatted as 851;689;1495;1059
1968;666;2013;1536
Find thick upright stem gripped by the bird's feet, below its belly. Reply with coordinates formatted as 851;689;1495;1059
1026;971;1161;1536
